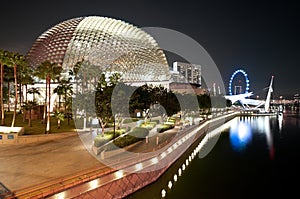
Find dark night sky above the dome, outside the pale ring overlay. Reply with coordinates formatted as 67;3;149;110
0;0;300;96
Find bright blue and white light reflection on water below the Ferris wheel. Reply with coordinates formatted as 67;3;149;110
229;116;280;159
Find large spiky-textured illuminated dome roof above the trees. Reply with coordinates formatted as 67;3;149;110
26;16;170;82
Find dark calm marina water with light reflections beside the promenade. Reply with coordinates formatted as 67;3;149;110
128;111;300;199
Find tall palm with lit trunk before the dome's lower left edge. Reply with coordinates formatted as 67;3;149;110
35;61;62;133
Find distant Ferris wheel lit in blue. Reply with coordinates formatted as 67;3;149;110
228;69;250;95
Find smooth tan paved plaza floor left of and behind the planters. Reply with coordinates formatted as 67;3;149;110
0;126;182;192
